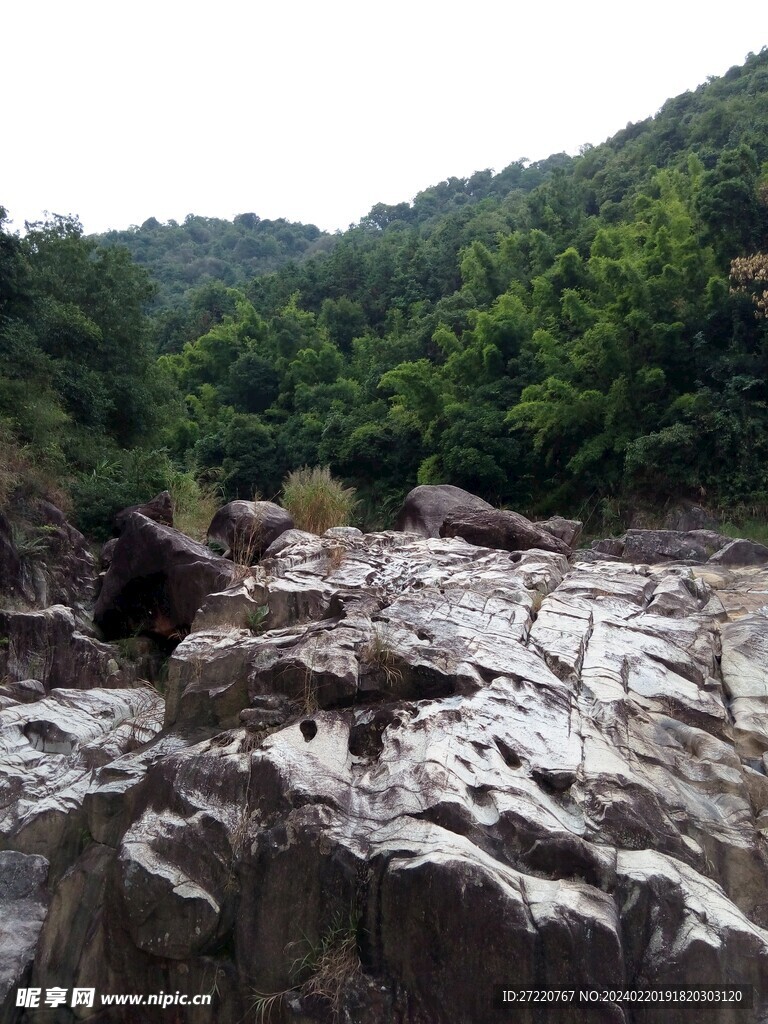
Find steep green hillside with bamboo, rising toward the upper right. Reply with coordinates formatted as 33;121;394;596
157;52;768;524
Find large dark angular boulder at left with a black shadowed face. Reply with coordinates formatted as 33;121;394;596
93;512;234;638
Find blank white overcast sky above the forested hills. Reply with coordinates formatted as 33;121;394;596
0;0;768;231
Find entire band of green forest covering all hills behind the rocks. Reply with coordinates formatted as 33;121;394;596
0;50;768;540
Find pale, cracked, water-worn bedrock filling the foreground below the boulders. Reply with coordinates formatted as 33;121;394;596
0;516;768;1024
